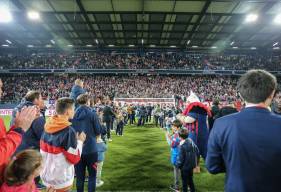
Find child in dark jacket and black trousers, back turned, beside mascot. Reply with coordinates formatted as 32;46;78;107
176;129;199;192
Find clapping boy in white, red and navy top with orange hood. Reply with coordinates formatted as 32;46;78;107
40;97;86;192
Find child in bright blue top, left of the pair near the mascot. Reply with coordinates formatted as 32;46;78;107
166;120;182;191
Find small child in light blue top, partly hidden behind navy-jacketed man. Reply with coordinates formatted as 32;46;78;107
96;135;107;187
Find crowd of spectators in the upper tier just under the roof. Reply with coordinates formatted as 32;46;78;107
0;52;281;71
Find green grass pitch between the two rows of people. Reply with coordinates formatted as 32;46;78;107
0;118;224;192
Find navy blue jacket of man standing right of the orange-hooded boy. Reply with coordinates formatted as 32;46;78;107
72;105;101;154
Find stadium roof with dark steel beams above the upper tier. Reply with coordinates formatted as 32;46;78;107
0;0;281;48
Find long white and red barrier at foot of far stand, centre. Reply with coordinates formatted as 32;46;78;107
113;98;176;106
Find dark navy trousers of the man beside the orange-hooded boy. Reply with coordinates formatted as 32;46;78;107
75;153;98;192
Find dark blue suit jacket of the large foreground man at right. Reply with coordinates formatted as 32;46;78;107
206;107;281;192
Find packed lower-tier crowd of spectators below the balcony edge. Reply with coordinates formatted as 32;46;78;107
1;75;237;102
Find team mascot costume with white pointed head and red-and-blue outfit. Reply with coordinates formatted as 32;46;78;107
177;92;211;172
